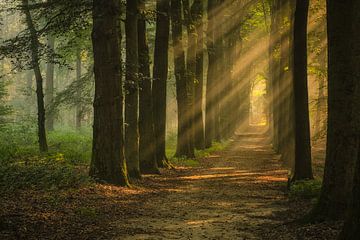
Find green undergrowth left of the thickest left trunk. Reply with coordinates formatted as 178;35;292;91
0;124;91;192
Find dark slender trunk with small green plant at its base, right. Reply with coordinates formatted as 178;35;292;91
292;0;313;181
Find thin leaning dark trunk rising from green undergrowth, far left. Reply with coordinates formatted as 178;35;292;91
22;0;48;152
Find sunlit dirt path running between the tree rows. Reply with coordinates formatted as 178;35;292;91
116;134;289;240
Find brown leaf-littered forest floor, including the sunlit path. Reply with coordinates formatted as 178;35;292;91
0;128;341;240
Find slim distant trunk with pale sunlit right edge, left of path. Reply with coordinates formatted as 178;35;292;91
192;0;205;149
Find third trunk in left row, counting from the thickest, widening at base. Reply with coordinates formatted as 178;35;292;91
138;0;160;174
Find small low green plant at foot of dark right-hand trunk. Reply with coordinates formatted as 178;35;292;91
289;180;321;199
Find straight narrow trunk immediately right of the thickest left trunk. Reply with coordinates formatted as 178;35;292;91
125;0;141;179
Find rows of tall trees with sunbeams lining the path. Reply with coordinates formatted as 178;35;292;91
0;0;360;240
